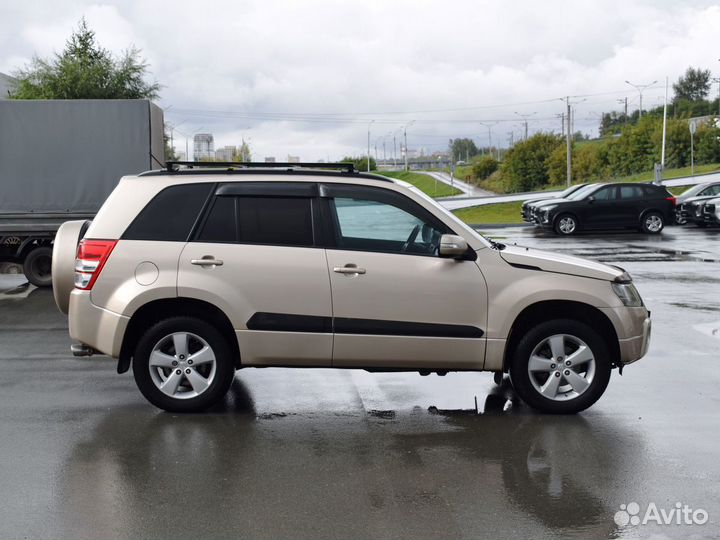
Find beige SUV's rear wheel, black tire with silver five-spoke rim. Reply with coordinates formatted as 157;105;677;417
133;317;235;412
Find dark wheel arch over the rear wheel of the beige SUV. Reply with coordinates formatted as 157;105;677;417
117;297;240;373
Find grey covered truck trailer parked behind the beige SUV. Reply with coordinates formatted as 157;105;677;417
0;99;165;287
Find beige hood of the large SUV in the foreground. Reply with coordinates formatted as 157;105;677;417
500;246;623;281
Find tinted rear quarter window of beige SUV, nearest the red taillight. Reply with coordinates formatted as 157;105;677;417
123;184;214;242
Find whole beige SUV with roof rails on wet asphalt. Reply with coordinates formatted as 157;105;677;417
52;163;650;413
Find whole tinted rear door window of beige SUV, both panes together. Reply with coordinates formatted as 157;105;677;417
197;196;314;247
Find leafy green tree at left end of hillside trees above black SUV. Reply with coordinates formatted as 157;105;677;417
500;133;564;191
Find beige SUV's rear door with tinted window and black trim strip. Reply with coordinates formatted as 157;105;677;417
178;182;332;366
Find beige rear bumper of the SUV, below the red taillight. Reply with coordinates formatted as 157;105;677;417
68;289;130;358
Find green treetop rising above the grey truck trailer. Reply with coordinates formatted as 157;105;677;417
11;18;160;99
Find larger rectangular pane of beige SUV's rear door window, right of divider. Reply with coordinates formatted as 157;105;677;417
237;197;313;246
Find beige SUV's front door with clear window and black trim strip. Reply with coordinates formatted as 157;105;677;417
323;185;487;369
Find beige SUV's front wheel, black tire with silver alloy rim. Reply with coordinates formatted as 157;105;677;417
510;319;612;414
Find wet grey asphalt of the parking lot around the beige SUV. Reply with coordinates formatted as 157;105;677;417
0;227;720;540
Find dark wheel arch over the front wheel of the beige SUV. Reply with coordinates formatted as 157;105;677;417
503;300;620;372
